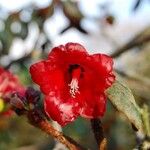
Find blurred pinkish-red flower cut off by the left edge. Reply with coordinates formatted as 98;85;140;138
0;67;25;97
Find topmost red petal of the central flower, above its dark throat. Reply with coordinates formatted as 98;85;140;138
48;43;89;68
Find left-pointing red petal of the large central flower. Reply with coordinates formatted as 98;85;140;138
30;60;64;94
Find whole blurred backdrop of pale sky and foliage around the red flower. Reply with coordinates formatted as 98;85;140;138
0;0;150;150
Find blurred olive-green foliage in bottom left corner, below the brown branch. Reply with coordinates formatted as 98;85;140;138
0;116;53;150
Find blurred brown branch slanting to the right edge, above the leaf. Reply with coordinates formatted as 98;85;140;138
110;30;150;58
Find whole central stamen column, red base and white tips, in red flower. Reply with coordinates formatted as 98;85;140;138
68;67;81;98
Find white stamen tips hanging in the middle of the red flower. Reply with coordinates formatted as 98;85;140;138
69;78;80;98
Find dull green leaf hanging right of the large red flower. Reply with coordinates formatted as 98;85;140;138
106;81;143;131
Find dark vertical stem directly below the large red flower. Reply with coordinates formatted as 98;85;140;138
91;118;107;150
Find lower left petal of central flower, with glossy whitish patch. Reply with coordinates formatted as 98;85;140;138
44;95;79;126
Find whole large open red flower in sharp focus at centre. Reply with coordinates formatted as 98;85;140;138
30;43;115;126
